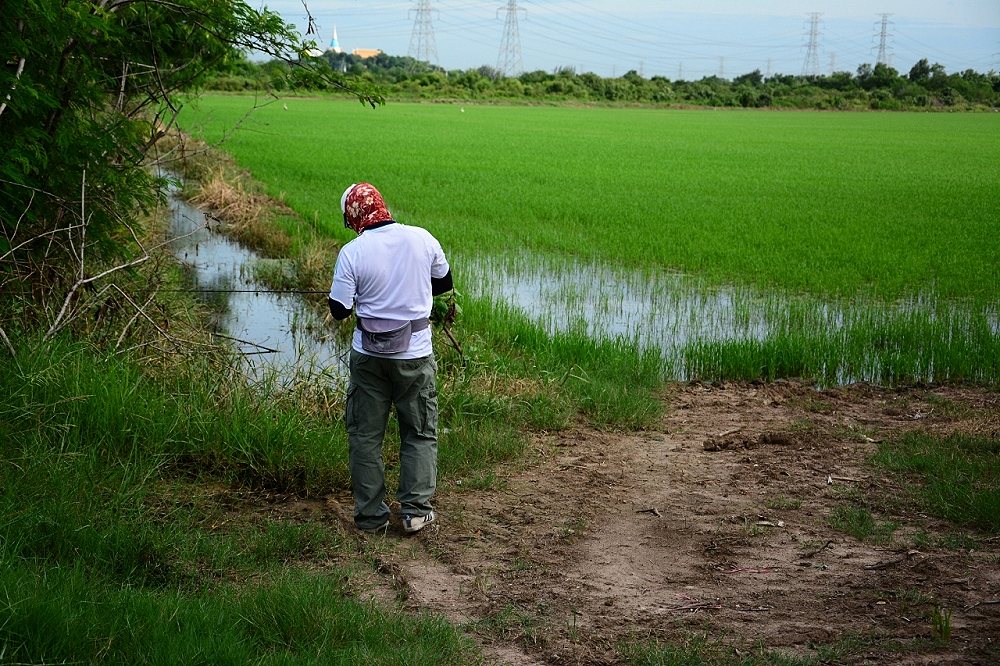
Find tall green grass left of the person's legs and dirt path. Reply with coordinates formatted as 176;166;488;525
0;339;478;664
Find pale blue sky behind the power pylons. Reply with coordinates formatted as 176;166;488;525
260;0;1000;80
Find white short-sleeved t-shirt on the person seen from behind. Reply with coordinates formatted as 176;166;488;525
330;222;450;359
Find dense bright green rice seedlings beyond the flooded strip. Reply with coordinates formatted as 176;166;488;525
181;96;1000;299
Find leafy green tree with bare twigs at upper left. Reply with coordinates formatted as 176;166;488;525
0;0;381;334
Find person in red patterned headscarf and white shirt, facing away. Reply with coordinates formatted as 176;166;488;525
328;183;453;533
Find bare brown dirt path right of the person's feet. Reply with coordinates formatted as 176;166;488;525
352;382;1000;665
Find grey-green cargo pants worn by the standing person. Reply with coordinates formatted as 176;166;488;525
345;350;437;529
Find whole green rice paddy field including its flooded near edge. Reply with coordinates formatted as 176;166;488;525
181;96;1000;385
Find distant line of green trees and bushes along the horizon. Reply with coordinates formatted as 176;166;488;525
206;51;1000;110
